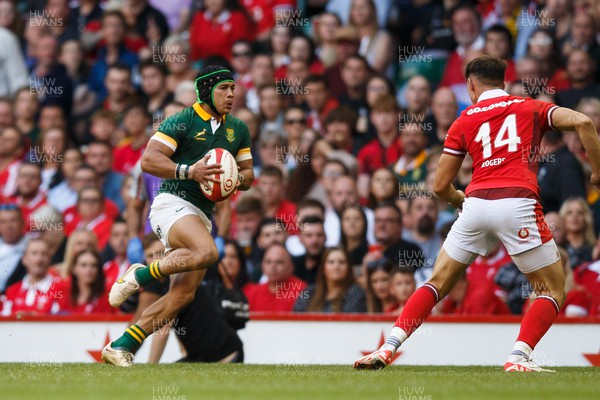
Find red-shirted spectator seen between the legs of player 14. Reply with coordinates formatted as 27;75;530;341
440;274;510;315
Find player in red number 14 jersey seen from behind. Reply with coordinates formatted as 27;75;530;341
354;56;600;372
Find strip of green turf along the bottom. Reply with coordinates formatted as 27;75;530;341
0;364;600;400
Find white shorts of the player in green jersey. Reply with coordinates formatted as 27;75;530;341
149;193;212;252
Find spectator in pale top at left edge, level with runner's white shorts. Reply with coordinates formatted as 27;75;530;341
0;203;28;293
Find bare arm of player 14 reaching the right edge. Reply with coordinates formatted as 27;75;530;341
552;107;600;187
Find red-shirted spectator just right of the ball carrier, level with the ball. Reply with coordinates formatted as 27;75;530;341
257;166;297;235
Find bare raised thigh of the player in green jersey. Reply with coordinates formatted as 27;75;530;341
168;214;217;255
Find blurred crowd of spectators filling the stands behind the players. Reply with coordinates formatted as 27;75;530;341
0;0;600;316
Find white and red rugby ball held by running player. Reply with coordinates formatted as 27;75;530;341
200;148;238;202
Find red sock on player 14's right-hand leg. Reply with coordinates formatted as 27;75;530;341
517;296;560;349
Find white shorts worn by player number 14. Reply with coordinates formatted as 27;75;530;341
443;197;560;273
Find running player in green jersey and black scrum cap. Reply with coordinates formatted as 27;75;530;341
102;66;254;367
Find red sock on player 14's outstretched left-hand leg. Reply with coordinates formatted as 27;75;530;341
394;283;439;336
